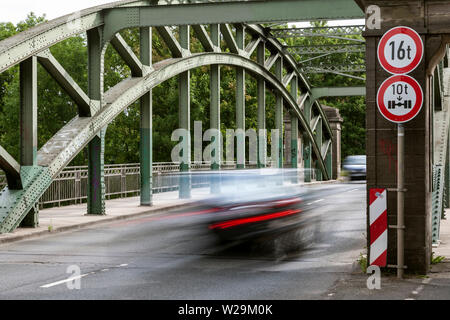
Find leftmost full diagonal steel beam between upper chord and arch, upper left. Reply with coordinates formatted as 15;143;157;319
37;50;94;117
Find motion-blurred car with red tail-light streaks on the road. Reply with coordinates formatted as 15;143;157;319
185;170;322;256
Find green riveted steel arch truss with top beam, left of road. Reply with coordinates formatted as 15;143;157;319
0;0;363;233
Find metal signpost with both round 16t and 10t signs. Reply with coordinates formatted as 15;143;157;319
377;26;424;278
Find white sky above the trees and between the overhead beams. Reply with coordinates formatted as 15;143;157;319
0;0;364;27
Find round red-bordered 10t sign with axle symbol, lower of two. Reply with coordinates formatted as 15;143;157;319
377;75;423;123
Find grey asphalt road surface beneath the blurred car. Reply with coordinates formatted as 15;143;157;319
0;183;366;300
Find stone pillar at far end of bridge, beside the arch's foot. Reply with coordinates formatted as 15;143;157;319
322;105;344;180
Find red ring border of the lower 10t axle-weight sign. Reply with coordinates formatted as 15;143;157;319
377;74;423;123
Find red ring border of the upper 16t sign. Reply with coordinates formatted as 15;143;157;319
377;26;423;74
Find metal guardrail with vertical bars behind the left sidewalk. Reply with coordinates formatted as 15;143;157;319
0;162;256;209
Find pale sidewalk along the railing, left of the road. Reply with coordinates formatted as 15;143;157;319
0;188;214;244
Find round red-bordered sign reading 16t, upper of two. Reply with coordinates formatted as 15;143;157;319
377;27;424;74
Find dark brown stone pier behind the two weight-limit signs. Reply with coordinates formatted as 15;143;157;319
357;0;450;273
